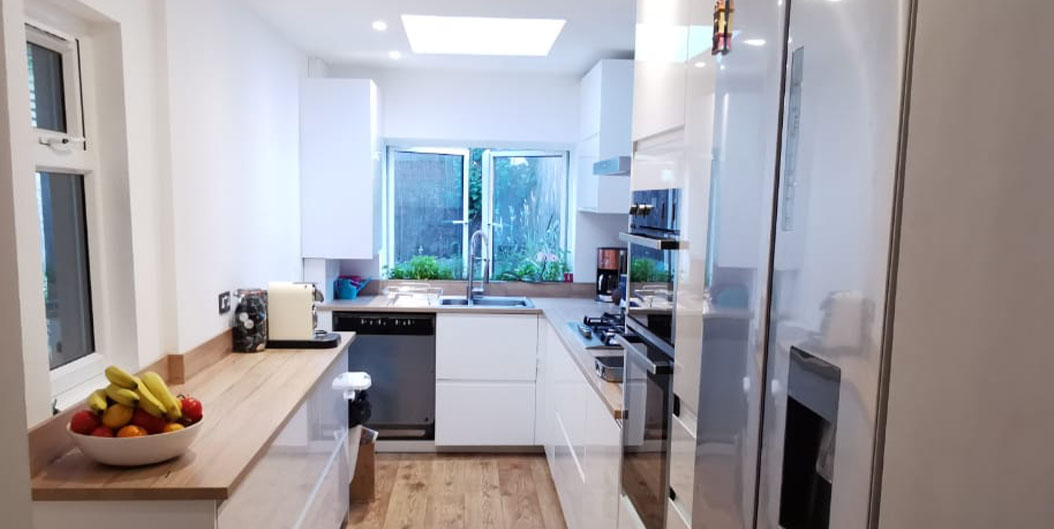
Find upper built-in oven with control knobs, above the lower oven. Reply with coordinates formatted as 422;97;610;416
620;189;682;355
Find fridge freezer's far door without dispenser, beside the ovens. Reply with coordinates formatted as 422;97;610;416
674;1;786;529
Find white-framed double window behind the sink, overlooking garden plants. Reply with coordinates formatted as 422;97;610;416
385;146;570;281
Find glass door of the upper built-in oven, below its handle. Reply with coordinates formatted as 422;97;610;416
626;242;677;349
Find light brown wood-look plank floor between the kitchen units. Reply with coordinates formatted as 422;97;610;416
348;453;566;529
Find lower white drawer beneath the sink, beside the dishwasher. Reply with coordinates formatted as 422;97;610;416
435;380;534;447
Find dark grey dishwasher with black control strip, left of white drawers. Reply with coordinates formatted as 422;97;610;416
333;312;435;440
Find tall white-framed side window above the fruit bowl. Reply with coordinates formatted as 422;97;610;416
25;24;104;387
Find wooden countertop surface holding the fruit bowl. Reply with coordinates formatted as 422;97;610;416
33;333;355;502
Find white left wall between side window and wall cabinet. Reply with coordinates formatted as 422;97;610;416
165;0;307;351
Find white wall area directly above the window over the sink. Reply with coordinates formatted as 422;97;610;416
329;64;579;149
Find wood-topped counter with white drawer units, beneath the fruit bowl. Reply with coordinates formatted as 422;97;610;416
33;333;357;529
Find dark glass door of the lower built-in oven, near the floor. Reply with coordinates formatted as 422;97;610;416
620;335;672;529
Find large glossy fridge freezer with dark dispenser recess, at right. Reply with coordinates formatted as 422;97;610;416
677;0;1054;529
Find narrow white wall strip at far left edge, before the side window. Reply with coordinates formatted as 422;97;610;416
0;0;32;520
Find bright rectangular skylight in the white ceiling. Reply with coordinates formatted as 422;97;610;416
403;15;567;57
